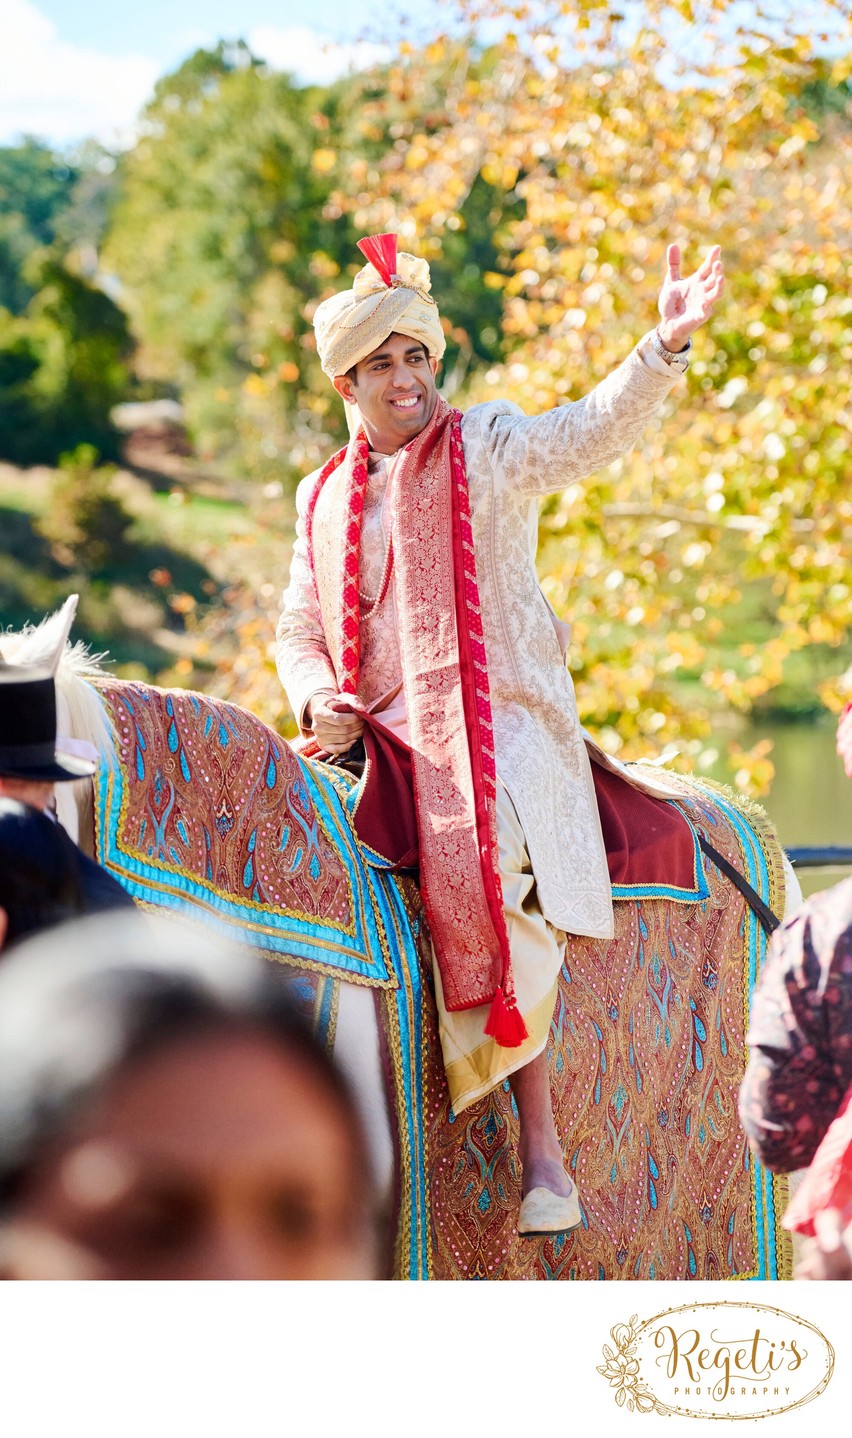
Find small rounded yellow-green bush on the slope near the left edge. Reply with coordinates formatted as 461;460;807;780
36;444;132;577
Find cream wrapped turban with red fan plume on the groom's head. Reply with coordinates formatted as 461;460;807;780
314;236;446;380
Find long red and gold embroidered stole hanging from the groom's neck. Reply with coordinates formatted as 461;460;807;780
307;400;527;1047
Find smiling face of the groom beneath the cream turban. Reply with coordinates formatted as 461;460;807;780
334;334;438;454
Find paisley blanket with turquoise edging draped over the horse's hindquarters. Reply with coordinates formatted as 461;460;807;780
425;781;792;1280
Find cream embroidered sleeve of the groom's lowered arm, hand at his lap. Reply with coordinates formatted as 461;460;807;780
275;476;338;733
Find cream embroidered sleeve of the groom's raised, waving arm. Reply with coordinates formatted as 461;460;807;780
479;341;681;495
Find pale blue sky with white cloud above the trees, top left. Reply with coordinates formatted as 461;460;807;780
0;0;436;145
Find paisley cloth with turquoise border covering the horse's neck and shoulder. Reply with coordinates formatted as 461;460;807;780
95;682;396;988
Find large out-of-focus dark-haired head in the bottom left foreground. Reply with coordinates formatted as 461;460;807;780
0;916;376;1278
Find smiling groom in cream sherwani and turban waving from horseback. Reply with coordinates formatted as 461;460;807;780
276;234;724;1234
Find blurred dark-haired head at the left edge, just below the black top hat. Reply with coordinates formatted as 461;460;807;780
0;798;86;948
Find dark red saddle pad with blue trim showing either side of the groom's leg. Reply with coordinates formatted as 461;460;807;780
329;715;697;893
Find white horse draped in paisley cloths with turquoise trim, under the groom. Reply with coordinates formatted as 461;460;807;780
8;601;800;1280
